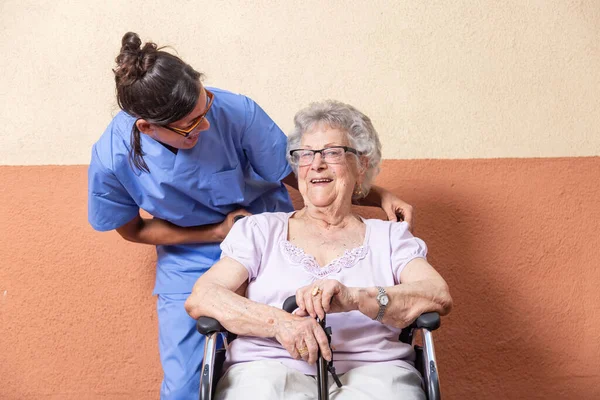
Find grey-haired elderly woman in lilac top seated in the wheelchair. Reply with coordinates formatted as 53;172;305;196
186;101;452;399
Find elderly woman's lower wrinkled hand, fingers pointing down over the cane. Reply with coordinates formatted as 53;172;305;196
275;315;331;364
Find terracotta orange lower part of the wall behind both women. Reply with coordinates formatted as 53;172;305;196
0;157;600;400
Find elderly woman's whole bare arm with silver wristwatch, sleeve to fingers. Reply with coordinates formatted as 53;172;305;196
296;258;452;328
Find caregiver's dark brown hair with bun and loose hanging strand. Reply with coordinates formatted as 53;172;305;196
113;32;202;172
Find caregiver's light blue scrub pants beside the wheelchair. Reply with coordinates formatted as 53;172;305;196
157;293;223;400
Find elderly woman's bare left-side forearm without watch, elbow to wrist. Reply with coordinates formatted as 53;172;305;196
185;283;290;337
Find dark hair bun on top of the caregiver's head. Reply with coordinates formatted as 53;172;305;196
113;32;158;85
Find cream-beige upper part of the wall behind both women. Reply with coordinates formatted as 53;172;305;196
0;0;600;165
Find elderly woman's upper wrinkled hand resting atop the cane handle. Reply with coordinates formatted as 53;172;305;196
296;279;358;319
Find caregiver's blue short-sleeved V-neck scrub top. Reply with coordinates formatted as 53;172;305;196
88;88;293;294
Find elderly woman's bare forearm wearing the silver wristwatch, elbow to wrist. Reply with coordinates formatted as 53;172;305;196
356;280;452;328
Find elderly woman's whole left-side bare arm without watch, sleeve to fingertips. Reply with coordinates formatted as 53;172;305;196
185;257;331;363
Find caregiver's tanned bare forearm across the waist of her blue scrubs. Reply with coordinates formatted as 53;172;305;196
117;218;224;245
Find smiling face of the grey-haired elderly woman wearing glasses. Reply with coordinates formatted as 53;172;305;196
298;124;363;210
